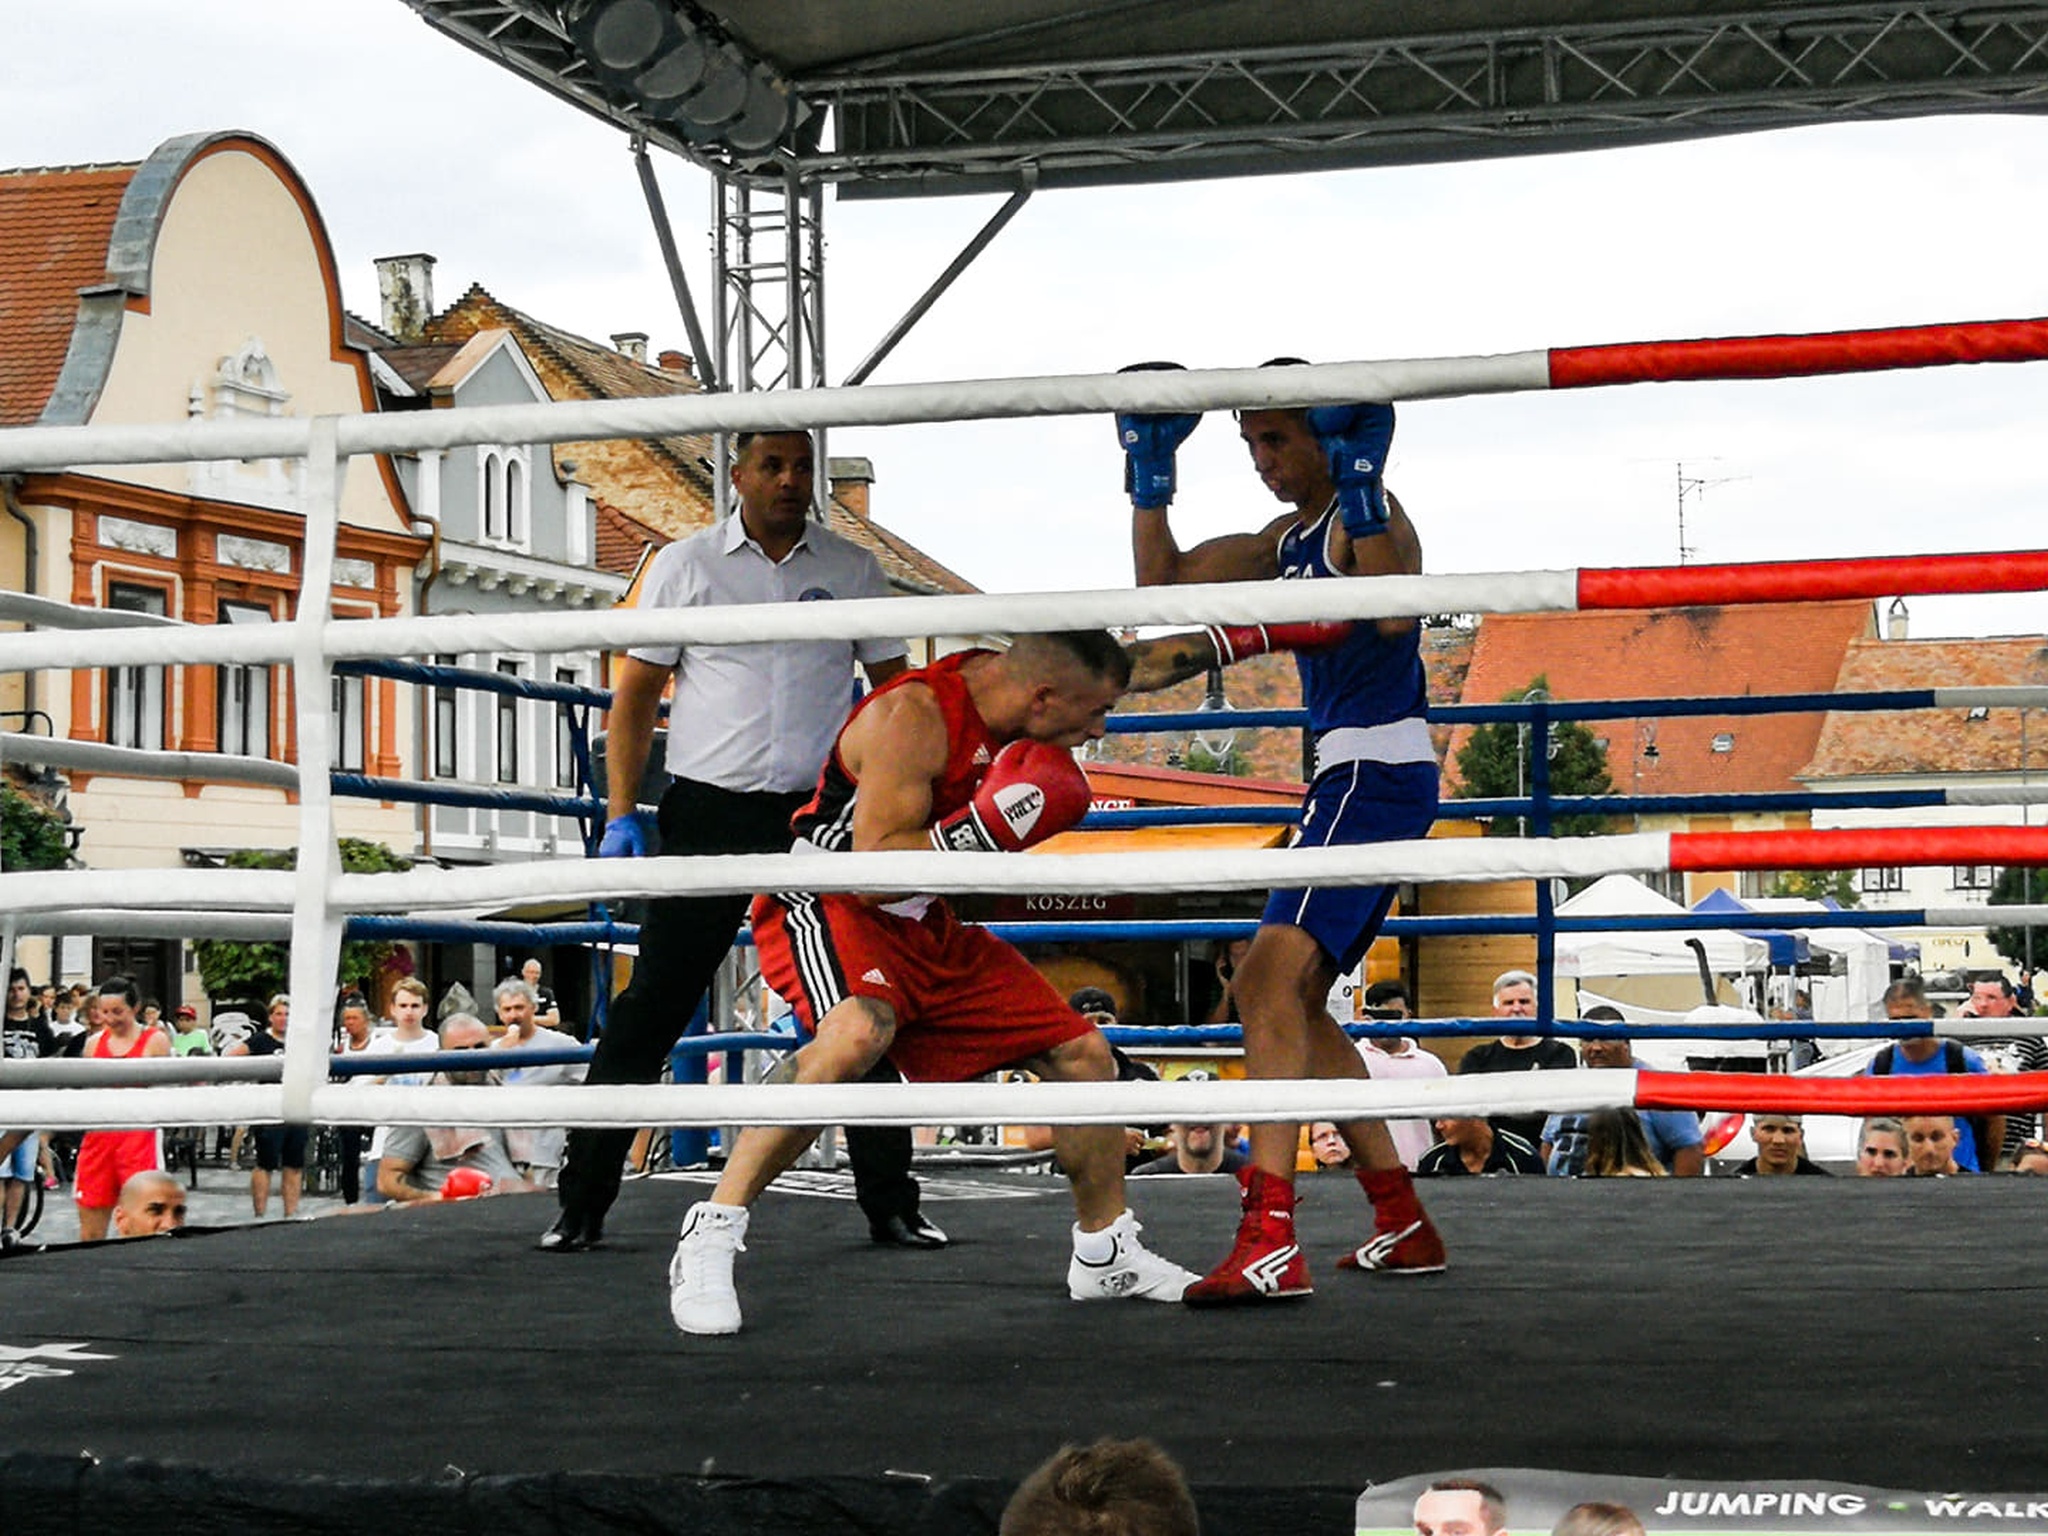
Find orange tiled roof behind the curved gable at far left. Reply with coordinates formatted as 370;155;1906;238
0;166;137;426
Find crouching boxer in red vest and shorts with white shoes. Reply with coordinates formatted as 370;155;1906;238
670;631;1194;1333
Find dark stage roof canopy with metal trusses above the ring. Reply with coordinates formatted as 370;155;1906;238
406;0;2048;197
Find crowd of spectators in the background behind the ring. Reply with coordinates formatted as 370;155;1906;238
12;950;2048;1245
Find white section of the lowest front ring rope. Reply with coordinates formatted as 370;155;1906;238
0;1069;1636;1130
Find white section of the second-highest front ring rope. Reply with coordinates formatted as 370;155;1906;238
0;569;1579;672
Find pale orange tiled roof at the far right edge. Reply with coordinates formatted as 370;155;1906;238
1800;635;2048;780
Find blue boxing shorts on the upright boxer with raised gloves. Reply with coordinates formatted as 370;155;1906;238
1260;760;1438;973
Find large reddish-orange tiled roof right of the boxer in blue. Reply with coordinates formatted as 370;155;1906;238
1444;602;1874;795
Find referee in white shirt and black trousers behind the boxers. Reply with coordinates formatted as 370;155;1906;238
541;432;946;1253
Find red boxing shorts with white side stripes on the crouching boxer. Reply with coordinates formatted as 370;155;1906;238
754;893;1094;1083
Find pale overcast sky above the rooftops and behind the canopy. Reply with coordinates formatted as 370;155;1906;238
0;0;2048;635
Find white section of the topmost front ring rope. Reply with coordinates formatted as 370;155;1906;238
0;350;1550;475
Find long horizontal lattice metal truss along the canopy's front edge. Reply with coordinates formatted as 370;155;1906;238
799;4;2048;197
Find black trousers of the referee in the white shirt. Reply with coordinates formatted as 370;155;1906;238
555;778;918;1223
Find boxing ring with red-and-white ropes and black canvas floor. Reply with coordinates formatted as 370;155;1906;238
0;319;2048;1536
